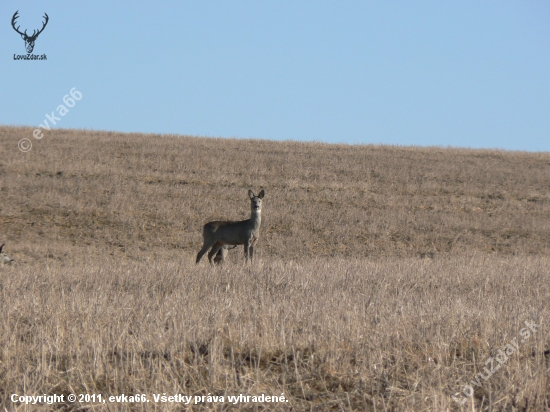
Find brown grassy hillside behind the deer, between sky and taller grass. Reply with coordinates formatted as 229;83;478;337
0;127;550;262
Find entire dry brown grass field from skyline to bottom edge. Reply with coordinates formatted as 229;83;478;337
0;127;550;411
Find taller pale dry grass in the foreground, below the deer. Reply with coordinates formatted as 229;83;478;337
0;255;550;411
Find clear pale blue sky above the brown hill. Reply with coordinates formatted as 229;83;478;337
0;0;550;151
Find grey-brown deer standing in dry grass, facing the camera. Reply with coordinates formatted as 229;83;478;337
195;190;264;266
